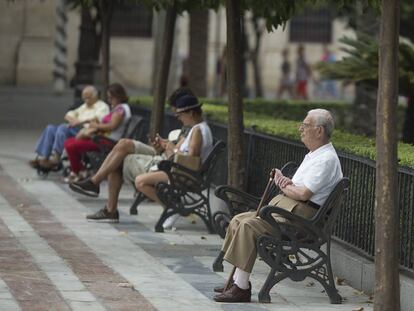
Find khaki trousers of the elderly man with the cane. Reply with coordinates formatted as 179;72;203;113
221;194;317;273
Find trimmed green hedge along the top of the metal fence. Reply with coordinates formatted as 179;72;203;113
130;97;414;168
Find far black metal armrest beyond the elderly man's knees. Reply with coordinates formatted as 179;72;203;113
214;185;260;216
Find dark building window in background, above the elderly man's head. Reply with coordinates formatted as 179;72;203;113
289;8;333;43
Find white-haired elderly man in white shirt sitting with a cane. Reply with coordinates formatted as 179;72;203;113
214;109;342;302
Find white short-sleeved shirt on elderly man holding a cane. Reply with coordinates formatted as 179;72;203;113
292;143;343;205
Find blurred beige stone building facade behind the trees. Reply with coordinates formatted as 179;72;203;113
0;0;352;97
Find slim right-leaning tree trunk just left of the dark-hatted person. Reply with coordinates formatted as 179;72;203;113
150;2;177;137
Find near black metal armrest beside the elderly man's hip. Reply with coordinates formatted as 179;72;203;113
259;205;326;245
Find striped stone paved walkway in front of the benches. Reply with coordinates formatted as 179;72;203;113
0;87;372;311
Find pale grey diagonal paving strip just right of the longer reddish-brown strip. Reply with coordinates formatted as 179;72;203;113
17;185;222;310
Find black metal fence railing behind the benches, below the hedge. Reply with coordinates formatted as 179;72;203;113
132;106;414;273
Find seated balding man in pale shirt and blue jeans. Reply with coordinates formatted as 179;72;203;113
29;85;109;168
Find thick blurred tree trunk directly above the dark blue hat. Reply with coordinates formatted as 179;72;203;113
188;9;209;97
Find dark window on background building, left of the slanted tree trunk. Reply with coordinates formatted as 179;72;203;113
111;3;152;38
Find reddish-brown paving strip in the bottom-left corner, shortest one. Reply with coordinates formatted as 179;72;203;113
0;219;70;310
